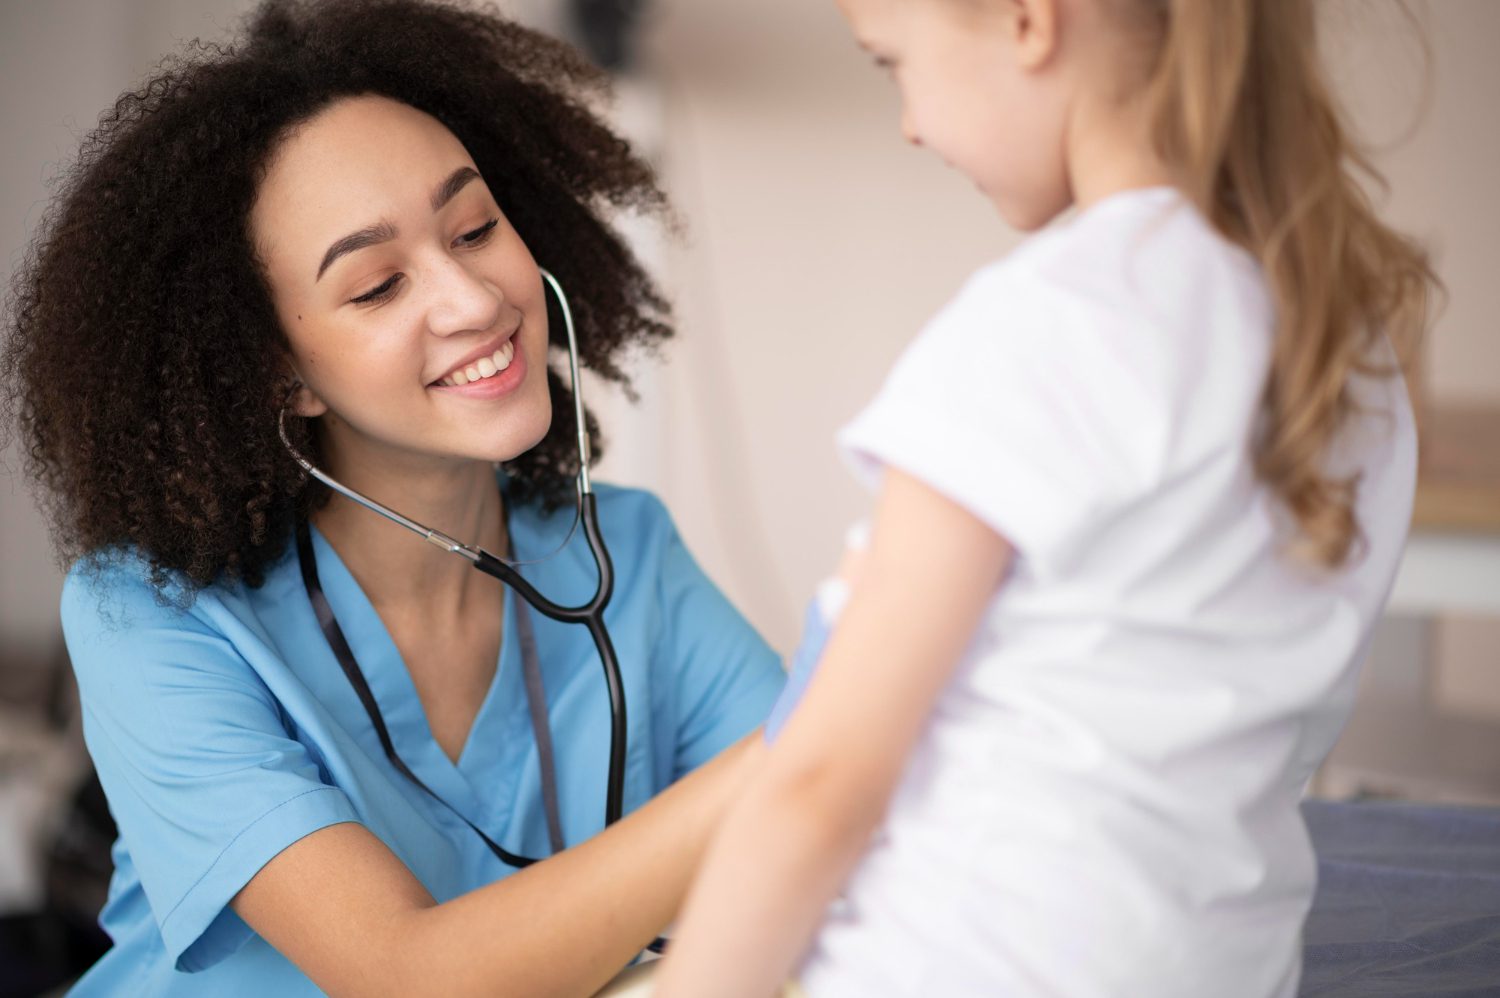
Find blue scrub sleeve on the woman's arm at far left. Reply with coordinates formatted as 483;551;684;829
62;567;359;971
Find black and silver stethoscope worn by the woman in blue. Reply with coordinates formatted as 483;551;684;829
278;269;626;867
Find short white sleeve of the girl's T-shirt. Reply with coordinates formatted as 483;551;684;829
839;266;1166;573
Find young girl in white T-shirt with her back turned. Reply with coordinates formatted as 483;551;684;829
659;0;1431;998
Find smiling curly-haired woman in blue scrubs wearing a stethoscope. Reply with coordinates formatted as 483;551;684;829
6;2;782;995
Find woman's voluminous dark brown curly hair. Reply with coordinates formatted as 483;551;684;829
0;0;672;591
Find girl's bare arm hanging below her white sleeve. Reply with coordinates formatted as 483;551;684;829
657;468;1011;998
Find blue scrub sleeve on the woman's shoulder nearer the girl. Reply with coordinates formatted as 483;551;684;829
653;500;786;779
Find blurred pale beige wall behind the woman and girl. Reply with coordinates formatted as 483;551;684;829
0;0;1500;650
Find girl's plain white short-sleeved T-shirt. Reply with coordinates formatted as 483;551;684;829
800;188;1416;998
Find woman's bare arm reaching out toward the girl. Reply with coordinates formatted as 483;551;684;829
231;731;764;996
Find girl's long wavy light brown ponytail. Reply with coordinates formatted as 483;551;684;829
1127;0;1437;567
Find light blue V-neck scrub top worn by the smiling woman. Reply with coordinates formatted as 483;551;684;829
62;485;783;998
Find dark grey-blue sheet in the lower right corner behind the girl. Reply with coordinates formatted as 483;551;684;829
1301;801;1500;998
